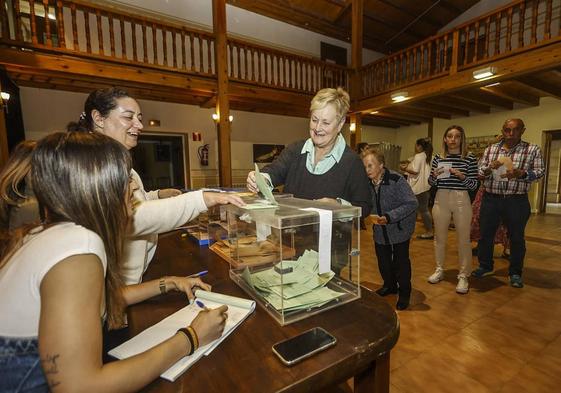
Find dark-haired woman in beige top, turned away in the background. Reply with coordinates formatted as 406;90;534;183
401;138;434;239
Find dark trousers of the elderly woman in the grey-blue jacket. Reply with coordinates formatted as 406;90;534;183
374;240;411;298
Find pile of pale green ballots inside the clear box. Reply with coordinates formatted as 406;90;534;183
242;250;344;311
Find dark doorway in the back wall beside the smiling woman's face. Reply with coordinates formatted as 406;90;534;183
131;132;190;191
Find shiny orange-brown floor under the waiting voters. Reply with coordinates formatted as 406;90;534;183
361;215;561;393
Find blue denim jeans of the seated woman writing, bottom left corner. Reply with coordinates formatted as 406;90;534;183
0;337;49;393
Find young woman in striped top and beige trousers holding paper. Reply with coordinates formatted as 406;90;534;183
428;126;477;294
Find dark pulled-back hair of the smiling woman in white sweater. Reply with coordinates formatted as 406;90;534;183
66;87;130;132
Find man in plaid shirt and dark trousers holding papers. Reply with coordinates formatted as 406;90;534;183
472;119;545;288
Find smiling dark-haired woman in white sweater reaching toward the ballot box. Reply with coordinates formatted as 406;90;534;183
67;88;244;284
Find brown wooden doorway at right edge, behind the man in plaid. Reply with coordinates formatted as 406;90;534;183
539;130;561;215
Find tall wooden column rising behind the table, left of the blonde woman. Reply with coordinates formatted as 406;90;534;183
212;0;232;187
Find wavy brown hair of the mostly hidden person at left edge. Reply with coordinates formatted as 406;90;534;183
0;141;41;229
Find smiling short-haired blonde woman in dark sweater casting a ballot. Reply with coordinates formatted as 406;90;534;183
247;87;371;274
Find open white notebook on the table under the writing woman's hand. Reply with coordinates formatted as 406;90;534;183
109;290;255;382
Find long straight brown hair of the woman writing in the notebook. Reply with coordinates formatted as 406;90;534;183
0;132;131;327
